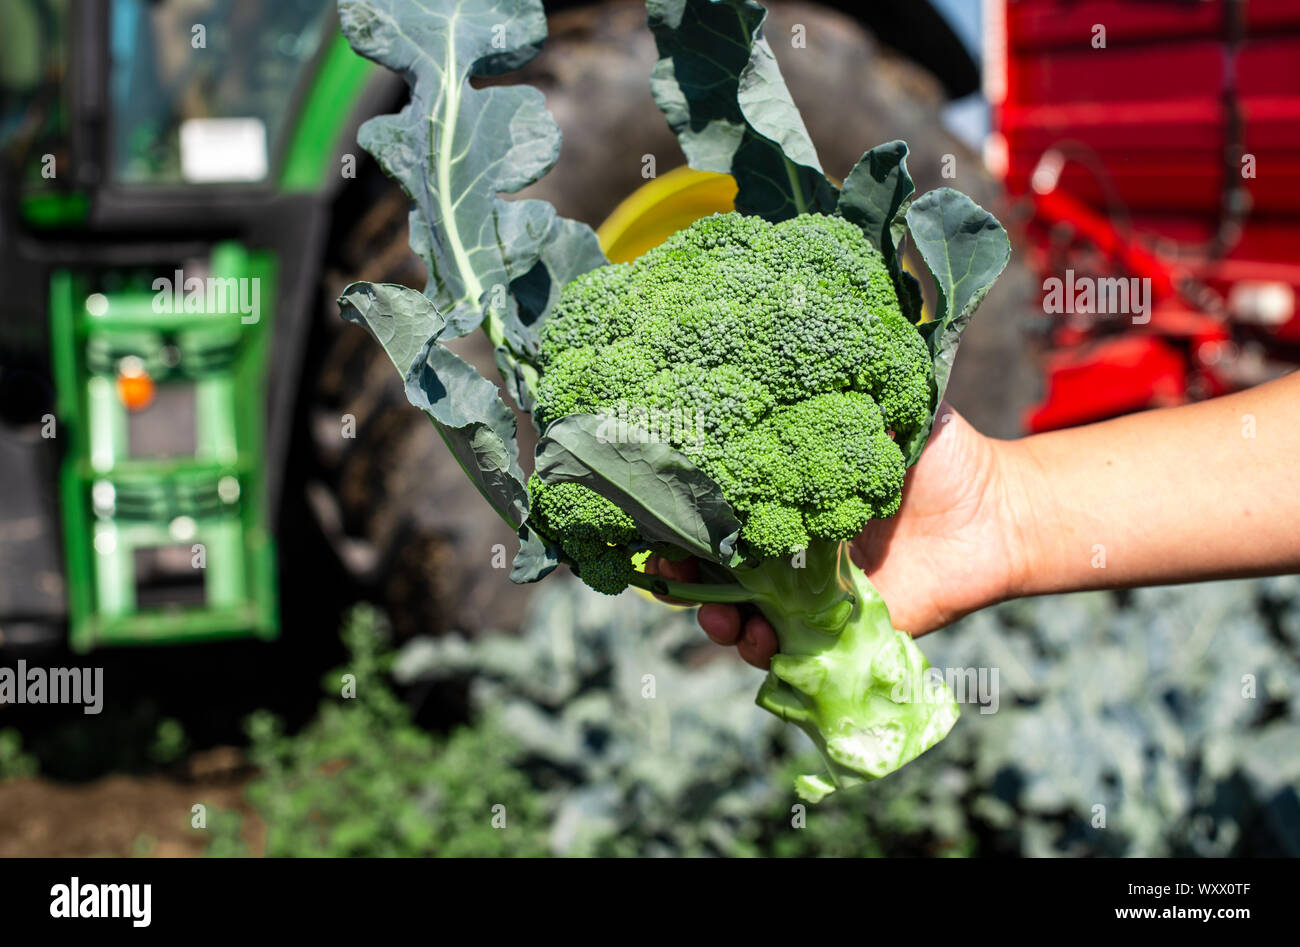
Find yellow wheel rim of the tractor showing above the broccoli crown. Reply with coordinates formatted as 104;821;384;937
595;167;736;263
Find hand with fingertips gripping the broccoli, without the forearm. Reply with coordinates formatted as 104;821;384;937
647;402;1028;669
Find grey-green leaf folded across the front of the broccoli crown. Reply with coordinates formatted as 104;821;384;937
537;414;740;565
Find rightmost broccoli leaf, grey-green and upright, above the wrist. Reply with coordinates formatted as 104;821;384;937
907;187;1011;405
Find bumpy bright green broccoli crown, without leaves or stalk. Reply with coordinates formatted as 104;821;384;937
534;213;933;592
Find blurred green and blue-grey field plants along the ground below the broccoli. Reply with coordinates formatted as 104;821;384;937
200;576;1300;856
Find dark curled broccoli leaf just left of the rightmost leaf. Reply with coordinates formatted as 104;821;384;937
836;140;922;324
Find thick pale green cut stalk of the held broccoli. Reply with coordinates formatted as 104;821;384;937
633;541;958;803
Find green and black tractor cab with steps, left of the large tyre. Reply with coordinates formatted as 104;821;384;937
0;0;421;650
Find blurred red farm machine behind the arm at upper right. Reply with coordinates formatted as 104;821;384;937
984;0;1300;431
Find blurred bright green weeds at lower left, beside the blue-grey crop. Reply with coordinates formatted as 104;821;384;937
208;606;547;857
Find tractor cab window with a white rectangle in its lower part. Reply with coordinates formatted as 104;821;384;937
109;0;333;185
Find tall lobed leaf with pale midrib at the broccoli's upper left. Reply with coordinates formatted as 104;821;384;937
339;0;605;351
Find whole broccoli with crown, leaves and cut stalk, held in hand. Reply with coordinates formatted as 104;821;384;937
339;0;1010;801
